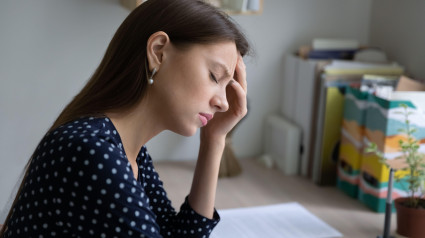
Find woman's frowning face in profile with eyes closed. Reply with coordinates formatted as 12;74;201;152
149;42;238;136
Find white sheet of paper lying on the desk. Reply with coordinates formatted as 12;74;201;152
210;203;342;238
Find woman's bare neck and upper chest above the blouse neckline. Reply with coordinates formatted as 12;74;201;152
106;98;165;162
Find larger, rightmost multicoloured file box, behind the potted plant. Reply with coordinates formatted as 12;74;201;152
358;95;425;212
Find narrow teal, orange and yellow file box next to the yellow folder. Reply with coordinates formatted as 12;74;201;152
337;87;368;198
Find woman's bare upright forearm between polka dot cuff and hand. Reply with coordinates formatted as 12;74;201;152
189;133;225;219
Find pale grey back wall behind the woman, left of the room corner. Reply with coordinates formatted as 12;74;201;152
0;0;371;216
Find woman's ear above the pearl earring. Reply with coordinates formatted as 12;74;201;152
146;31;170;71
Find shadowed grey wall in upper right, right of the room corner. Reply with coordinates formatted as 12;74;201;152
370;0;425;79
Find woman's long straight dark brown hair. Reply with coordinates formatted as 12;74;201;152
0;0;249;236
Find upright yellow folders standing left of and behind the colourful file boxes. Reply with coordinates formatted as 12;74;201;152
308;60;404;185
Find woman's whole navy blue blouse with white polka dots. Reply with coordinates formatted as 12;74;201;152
5;117;220;237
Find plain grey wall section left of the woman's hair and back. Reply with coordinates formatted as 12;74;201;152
0;0;128;219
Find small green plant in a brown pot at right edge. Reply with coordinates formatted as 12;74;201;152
366;104;425;238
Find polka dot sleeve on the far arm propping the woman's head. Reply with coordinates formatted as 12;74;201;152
140;148;220;237
